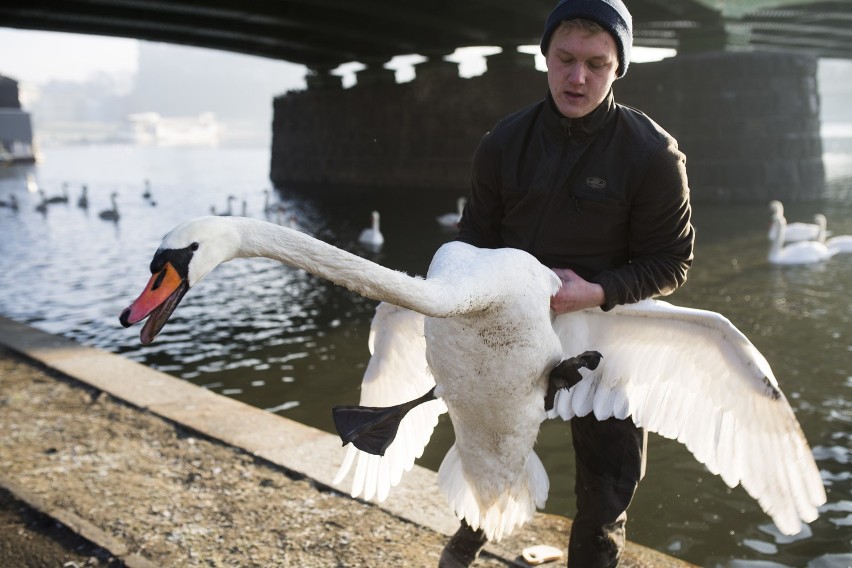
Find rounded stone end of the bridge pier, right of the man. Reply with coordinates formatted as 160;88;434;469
614;51;825;202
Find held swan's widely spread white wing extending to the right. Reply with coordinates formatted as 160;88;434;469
550;300;826;534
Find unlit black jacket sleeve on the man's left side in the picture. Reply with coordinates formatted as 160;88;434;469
456;133;503;248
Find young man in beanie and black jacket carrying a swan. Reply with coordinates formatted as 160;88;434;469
440;0;694;568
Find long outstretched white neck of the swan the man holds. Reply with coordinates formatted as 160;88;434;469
231;218;458;317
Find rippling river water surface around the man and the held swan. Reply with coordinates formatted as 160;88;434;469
0;147;852;568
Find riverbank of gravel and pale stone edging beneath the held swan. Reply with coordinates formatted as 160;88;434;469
0;318;685;568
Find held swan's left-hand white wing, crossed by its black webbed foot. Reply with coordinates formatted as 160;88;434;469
334;302;447;501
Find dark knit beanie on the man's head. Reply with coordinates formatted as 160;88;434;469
541;0;633;77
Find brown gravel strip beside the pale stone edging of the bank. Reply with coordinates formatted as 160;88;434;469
0;349;507;567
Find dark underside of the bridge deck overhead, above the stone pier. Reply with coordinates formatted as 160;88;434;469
0;0;852;71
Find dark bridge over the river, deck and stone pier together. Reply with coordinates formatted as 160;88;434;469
0;0;852;201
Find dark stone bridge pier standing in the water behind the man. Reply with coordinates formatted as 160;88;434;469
271;51;825;203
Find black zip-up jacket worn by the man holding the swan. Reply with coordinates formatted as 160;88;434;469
458;91;694;310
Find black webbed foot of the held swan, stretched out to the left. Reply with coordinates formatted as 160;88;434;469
331;387;435;456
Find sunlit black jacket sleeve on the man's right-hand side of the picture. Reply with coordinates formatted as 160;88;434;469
592;139;695;311
